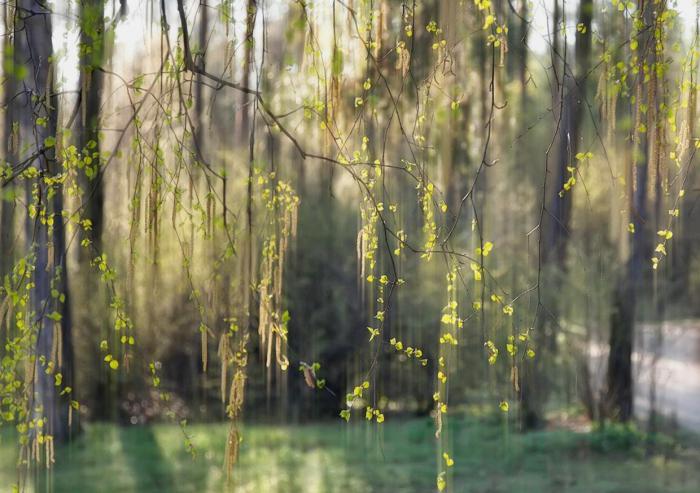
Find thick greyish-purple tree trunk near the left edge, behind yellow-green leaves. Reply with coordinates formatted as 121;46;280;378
18;0;73;443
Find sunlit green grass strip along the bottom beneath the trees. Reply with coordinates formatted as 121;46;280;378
0;418;700;493
